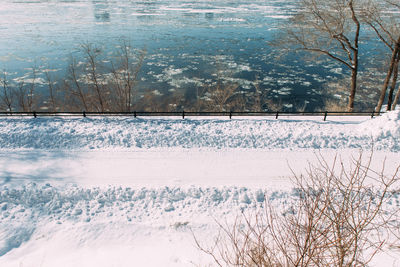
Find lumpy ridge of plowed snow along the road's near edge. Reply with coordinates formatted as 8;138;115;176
0;183;264;229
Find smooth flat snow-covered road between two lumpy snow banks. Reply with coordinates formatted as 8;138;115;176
0;149;400;189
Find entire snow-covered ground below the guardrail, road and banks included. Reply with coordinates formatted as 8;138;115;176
0;111;400;267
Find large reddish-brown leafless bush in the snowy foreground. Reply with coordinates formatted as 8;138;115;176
196;153;399;266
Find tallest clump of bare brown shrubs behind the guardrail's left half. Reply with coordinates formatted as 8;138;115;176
64;40;145;112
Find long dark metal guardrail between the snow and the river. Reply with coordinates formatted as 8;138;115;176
0;111;384;121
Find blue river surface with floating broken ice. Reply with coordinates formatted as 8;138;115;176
0;0;342;108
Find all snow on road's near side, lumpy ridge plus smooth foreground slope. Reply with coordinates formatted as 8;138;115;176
0;184;282;267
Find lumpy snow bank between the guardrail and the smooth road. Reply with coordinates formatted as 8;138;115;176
0;111;400;151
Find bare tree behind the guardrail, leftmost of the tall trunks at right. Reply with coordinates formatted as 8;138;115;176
280;0;363;111
